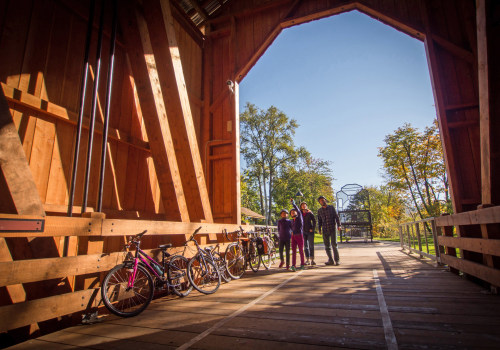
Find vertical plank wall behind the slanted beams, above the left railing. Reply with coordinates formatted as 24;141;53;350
0;0;202;219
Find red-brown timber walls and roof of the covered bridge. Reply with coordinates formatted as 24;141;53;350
0;0;500;346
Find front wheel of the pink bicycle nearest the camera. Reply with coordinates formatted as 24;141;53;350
101;264;154;317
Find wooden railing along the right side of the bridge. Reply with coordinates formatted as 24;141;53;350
399;206;500;291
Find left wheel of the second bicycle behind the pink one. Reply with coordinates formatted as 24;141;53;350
188;254;221;294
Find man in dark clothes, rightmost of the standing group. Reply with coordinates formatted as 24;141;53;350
318;196;342;265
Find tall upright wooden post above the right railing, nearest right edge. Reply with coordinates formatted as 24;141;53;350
476;0;492;204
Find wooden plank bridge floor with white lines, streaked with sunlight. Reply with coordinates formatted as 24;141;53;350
6;242;500;350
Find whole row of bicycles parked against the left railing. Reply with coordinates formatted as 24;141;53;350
101;227;277;317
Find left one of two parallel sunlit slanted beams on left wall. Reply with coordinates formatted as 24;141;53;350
119;5;189;222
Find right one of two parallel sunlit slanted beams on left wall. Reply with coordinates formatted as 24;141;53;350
160;0;213;222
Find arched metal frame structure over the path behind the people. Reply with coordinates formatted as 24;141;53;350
336;184;373;242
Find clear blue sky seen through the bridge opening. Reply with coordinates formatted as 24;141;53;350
240;11;436;191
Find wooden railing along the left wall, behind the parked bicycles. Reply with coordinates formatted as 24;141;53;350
0;214;253;332
